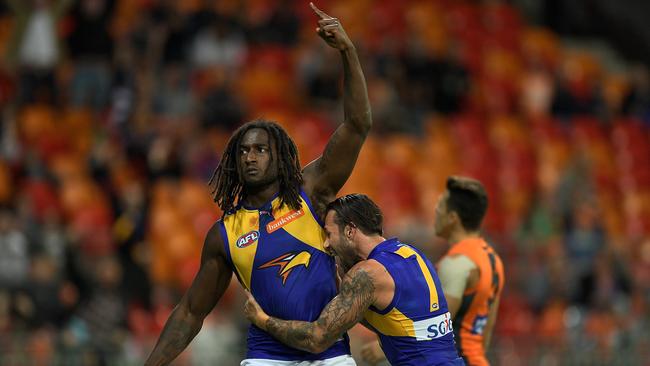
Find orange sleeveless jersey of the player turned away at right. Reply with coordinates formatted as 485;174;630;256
447;238;504;366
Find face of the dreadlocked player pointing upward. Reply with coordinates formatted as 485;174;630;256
238;128;278;188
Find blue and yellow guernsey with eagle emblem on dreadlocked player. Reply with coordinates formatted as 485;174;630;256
219;190;350;361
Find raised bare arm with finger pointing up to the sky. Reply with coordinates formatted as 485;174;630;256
303;4;372;217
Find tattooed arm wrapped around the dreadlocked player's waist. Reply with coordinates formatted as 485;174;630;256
244;261;376;353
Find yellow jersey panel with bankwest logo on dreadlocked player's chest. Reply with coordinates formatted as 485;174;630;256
272;198;325;252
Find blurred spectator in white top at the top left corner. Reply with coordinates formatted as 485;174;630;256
7;0;73;104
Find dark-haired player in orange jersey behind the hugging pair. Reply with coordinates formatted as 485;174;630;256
362;177;504;366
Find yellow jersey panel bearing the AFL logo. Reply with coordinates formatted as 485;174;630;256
223;209;259;290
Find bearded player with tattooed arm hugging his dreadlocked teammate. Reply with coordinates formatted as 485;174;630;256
244;194;464;366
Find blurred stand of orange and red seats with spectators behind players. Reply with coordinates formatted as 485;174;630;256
0;0;650;365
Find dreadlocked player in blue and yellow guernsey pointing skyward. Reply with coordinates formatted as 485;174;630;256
146;4;372;366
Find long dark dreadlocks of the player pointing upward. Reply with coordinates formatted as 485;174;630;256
208;119;303;215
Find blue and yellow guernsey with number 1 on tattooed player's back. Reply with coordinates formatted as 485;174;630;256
364;238;465;366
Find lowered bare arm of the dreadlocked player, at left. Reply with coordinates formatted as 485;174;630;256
145;224;232;366
